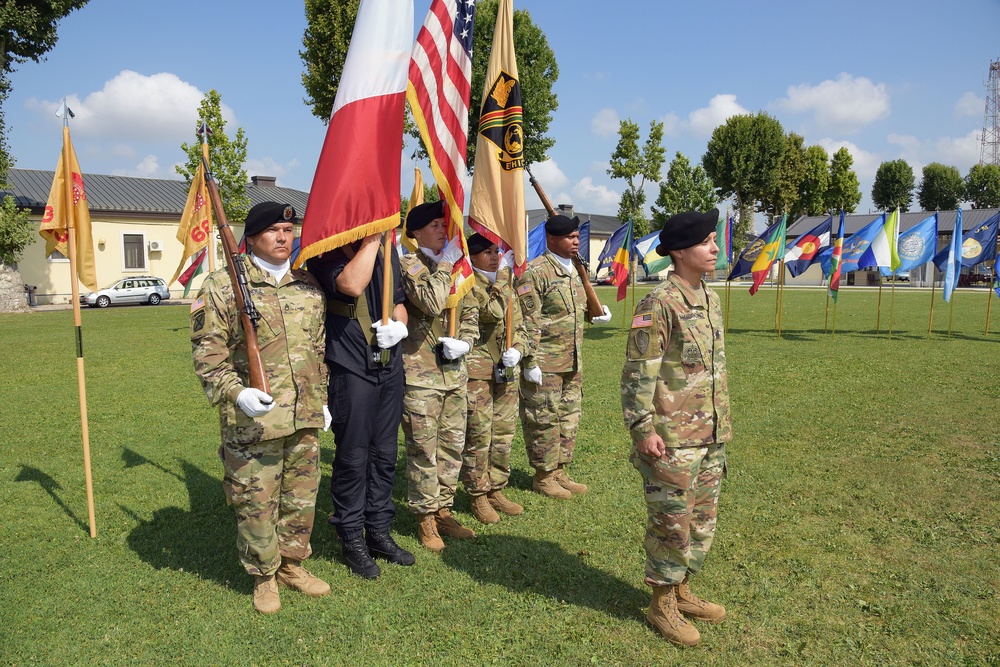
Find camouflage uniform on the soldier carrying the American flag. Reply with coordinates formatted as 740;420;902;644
400;251;478;514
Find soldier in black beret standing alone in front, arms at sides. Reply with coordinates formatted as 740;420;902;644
622;209;732;646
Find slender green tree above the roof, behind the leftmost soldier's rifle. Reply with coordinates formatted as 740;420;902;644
174;88;250;223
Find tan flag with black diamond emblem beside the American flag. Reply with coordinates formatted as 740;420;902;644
469;0;528;274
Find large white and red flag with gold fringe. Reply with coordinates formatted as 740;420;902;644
295;0;413;267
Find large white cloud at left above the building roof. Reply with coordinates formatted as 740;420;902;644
26;70;235;142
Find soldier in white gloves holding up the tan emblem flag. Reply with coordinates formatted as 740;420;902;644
461;234;525;523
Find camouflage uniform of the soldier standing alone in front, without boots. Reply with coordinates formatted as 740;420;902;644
622;274;732;586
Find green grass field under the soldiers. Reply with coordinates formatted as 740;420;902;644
0;286;1000;667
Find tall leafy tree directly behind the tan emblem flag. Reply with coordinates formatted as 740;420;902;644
465;0;559;172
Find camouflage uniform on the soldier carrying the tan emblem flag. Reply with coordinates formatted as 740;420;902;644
462;269;525;496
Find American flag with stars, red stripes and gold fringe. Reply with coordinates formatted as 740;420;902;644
406;0;475;307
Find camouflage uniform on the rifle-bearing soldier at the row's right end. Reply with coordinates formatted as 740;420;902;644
516;250;587;471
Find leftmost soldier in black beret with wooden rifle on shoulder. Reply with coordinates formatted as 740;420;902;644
191;202;330;613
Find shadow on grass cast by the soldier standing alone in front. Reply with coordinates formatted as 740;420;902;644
441;535;649;621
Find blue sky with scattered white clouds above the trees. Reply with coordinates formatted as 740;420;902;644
4;0;1000;224
